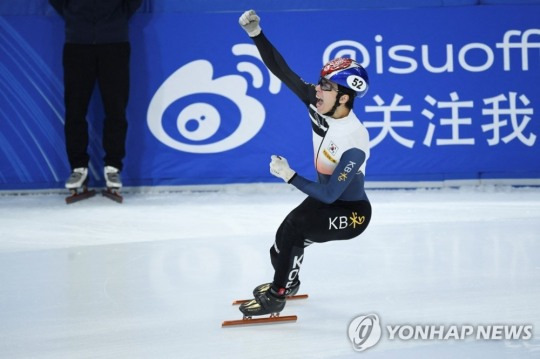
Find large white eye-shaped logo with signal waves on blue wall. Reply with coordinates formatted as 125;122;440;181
147;44;281;153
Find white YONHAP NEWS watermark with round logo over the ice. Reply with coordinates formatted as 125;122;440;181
348;314;534;352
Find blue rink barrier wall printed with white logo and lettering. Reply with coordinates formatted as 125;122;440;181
0;5;540;190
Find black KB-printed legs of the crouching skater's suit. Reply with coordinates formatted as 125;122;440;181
270;197;371;288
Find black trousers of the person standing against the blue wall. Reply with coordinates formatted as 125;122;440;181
63;42;131;170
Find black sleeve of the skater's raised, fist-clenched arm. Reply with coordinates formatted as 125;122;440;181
252;32;315;106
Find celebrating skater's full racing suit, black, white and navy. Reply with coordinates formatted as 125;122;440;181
253;32;371;290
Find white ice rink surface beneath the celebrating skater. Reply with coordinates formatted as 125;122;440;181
0;184;540;359
